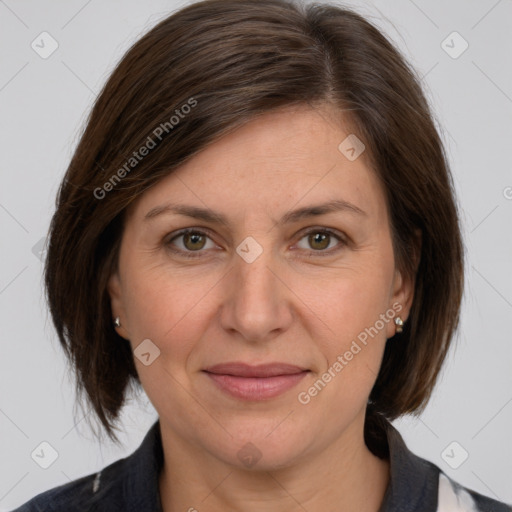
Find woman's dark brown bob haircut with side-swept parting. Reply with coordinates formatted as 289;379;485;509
44;0;464;442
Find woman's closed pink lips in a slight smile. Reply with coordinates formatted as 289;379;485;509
204;363;309;400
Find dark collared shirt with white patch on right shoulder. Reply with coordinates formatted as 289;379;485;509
13;421;512;512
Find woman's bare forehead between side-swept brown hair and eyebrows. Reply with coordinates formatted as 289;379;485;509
129;107;385;222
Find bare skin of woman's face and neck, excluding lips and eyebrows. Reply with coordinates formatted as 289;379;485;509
109;106;414;512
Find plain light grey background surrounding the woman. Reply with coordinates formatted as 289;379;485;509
0;0;512;511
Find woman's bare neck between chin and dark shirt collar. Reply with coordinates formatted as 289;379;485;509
159;417;389;512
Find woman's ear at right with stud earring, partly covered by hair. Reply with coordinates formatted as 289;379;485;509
387;229;422;338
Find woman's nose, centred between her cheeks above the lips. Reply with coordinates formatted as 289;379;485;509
220;243;293;342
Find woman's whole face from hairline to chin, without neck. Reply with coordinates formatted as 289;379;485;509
109;107;412;468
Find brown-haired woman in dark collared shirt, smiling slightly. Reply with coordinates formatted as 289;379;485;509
12;0;512;512
